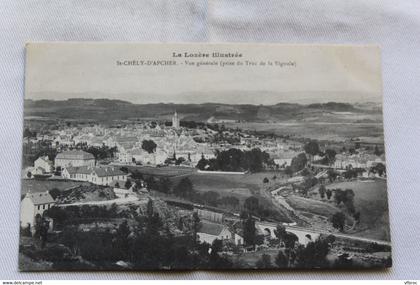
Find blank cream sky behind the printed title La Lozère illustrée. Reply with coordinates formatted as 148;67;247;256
25;43;382;105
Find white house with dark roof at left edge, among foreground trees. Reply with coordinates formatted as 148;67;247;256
20;191;54;230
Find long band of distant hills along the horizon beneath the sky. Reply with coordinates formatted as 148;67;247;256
25;99;380;122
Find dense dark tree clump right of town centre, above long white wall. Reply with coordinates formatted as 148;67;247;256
196;148;274;172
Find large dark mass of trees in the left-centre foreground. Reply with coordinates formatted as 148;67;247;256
55;200;232;270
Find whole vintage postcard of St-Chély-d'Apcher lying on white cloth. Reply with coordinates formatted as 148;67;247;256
19;43;392;271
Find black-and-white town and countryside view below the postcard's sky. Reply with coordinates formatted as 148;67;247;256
19;99;391;271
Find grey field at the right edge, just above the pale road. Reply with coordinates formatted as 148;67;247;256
327;180;390;240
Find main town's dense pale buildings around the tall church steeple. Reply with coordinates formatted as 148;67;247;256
26;112;308;172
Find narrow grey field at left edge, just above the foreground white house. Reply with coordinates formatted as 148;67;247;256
21;179;90;195
